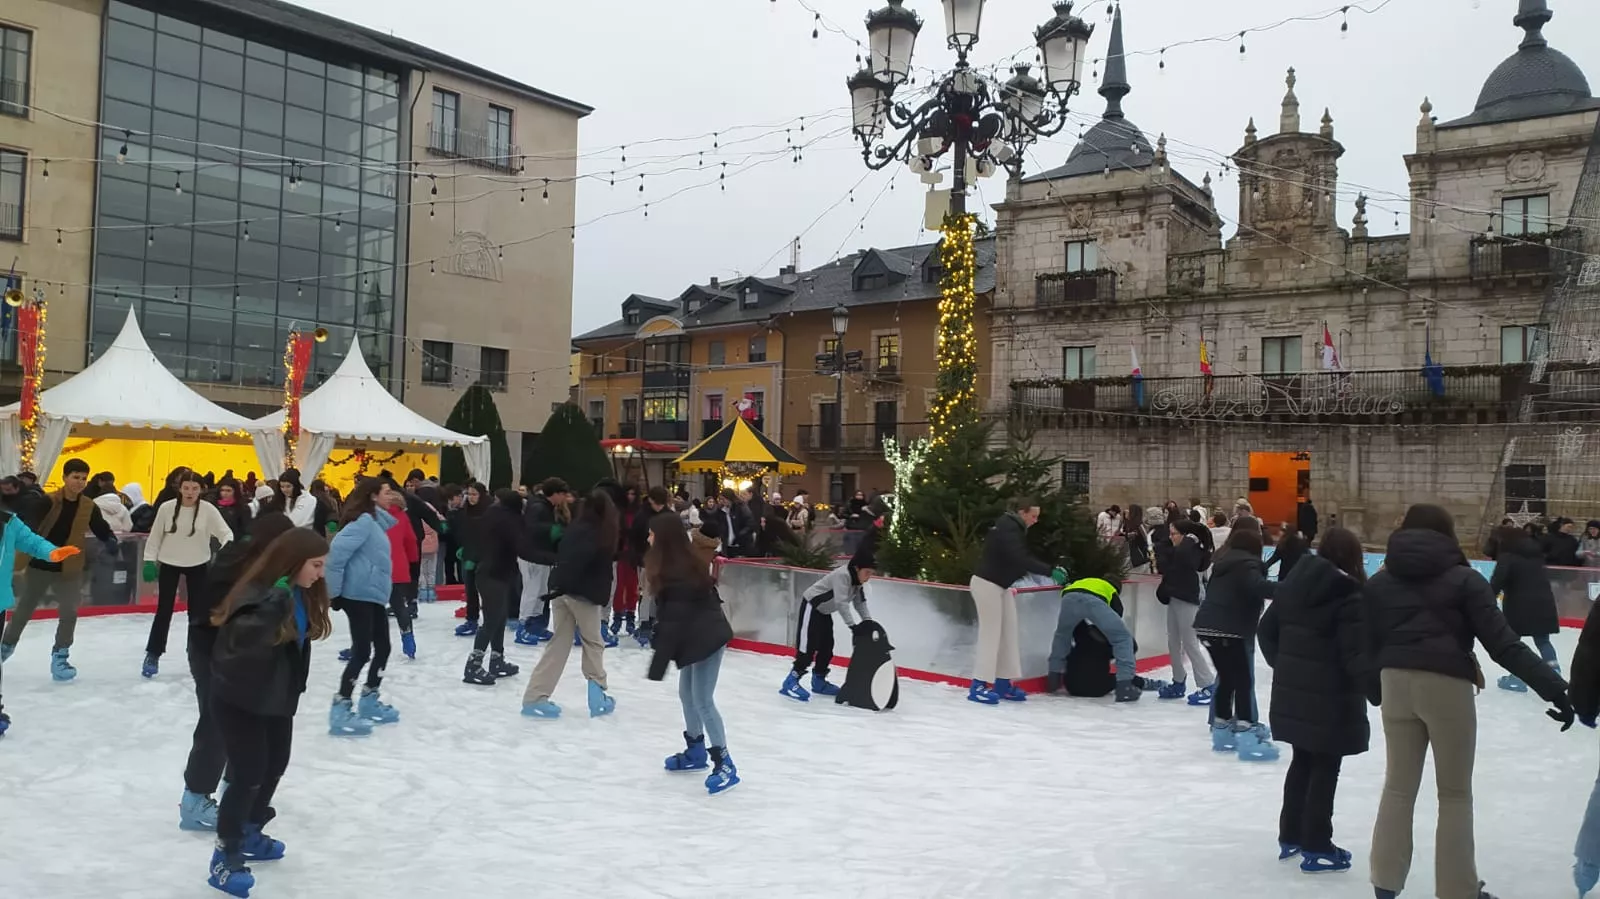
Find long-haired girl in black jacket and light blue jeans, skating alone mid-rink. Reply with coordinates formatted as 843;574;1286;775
645;512;736;795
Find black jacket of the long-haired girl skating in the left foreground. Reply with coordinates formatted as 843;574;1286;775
211;587;310;717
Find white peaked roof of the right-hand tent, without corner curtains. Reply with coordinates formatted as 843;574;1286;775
256;342;488;446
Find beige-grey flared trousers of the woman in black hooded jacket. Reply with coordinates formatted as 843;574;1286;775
1371;669;1478;899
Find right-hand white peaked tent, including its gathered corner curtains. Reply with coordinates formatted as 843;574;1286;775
254;342;490;480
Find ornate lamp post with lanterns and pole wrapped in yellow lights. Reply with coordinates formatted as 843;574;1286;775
846;0;1094;443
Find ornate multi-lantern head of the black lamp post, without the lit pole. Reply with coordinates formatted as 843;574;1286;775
846;0;1094;202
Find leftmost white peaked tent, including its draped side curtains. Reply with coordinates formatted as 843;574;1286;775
0;309;273;478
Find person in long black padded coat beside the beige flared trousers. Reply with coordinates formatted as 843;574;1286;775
1261;528;1371;873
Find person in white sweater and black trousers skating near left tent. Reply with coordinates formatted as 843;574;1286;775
142;472;234;677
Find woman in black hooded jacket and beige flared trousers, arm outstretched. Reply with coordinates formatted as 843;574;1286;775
1363;505;1573;899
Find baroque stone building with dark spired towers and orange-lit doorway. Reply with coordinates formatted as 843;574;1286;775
990;0;1600;539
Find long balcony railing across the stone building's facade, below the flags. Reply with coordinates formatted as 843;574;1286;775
1011;363;1548;419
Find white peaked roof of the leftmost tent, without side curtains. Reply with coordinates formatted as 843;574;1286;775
0;309;262;432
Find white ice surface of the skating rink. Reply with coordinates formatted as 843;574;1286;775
0;605;1597;899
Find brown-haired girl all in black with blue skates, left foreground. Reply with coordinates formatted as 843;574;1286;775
208;528;333;896
